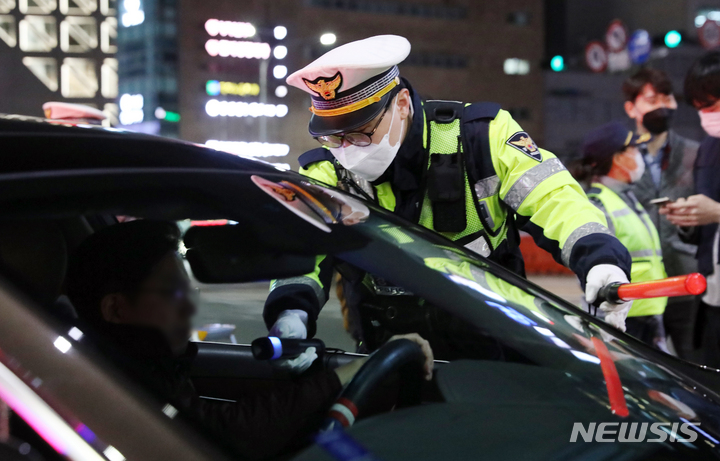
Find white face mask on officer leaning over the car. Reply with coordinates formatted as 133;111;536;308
330;99;405;181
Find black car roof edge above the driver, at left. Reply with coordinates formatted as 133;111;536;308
0;114;279;174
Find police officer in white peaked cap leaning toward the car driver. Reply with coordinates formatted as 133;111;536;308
264;35;630;368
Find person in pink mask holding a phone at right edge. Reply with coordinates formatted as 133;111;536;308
660;51;720;368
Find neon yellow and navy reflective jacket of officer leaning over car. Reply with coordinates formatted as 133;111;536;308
264;85;630;334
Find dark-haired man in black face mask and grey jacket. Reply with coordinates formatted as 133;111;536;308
622;68;699;359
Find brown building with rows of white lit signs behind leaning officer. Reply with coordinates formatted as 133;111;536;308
178;0;544;169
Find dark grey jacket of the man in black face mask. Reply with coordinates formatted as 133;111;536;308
633;130;699;277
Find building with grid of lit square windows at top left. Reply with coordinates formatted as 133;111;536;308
0;0;118;123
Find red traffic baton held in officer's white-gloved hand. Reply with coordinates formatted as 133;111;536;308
598;272;707;304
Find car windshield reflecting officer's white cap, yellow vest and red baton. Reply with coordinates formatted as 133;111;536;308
177;176;718;442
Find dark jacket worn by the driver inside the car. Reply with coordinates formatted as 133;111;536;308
89;324;342;459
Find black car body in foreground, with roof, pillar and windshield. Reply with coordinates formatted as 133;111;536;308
0;112;720;460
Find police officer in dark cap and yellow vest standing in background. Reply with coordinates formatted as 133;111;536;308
571;122;668;352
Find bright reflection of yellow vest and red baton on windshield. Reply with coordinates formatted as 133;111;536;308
334;199;720;440
